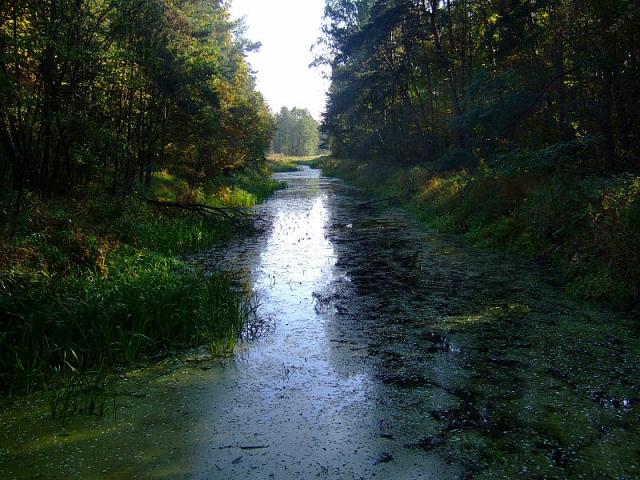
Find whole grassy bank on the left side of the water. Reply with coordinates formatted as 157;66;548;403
0;165;283;402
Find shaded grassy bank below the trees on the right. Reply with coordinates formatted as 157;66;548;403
316;158;640;313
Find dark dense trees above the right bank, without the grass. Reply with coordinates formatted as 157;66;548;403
318;0;640;171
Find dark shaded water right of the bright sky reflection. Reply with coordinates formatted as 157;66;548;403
317;171;640;478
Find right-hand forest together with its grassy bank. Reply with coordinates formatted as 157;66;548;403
316;0;640;308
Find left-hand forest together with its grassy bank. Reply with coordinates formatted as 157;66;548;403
0;0;282;396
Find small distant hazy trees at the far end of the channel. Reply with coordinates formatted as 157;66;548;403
271;107;320;157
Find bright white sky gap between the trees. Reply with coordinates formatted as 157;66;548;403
231;0;328;120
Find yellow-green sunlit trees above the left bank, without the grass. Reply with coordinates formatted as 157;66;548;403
0;0;273;204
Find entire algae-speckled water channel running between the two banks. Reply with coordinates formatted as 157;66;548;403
0;168;640;479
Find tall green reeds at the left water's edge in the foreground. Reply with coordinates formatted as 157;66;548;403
0;247;249;391
